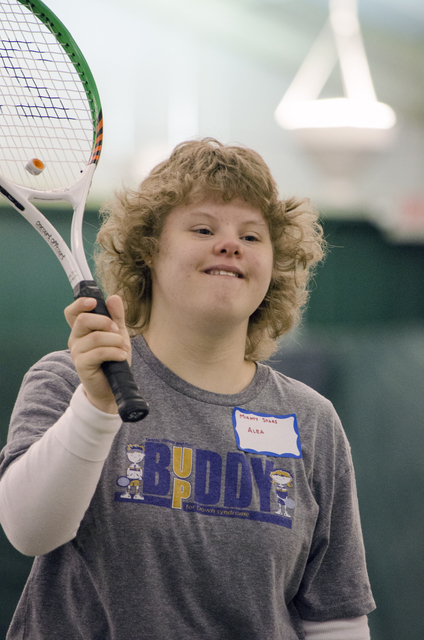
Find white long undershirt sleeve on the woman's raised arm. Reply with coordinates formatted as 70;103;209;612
0;364;121;556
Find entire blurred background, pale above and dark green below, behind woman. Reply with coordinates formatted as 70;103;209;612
0;0;424;640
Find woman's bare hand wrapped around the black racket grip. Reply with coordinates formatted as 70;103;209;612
65;295;131;413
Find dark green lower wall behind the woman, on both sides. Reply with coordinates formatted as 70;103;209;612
0;209;424;640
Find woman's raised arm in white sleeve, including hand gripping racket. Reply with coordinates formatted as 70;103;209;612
0;296;131;556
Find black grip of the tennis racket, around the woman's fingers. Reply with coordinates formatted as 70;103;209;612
74;280;149;422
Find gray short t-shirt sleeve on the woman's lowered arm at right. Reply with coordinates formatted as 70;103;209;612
295;413;375;622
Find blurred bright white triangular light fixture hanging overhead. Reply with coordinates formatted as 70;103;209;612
275;0;396;152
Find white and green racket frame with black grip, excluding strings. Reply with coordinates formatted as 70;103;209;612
0;0;149;422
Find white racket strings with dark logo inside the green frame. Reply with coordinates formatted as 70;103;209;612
0;0;93;189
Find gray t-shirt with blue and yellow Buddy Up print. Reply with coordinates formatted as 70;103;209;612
0;337;374;640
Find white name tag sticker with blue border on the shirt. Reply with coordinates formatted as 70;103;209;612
233;407;302;458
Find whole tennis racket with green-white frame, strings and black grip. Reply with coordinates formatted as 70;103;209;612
0;0;149;422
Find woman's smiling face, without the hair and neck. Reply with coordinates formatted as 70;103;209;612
152;199;273;330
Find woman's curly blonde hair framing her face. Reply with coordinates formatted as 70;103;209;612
95;138;325;361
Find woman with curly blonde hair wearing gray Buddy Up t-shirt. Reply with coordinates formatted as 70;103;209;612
0;139;374;640
